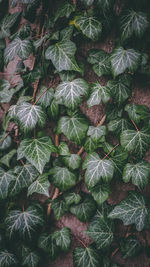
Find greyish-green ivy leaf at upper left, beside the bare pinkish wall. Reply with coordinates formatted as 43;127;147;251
4;37;33;65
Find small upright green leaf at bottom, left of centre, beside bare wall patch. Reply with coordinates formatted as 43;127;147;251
52;227;71;252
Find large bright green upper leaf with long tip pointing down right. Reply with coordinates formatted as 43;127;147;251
45;40;81;72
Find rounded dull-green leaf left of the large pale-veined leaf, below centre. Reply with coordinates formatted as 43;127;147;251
49;167;77;191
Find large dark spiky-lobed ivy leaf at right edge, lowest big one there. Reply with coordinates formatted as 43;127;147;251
108;192;147;231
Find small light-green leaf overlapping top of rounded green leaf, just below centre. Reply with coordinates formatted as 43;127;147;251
62;154;81;170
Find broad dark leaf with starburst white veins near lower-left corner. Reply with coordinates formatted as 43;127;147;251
5;206;44;239
